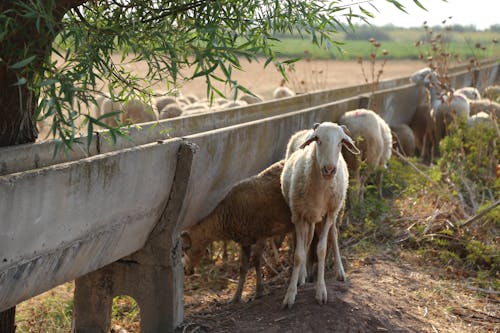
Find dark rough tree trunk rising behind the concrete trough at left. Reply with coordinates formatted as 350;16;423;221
0;0;87;147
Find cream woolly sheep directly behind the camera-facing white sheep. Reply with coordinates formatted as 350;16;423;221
338;109;392;198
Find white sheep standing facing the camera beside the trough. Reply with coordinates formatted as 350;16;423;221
281;122;359;308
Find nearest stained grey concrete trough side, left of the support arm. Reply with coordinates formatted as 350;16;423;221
0;139;182;311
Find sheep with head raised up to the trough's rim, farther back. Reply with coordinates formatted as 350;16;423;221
409;68;437;163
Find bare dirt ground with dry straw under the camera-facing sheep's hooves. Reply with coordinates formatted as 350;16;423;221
176;255;500;333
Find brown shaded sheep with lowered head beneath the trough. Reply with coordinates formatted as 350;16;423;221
182;160;293;302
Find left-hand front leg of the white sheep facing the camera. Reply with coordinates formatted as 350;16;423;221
282;221;309;309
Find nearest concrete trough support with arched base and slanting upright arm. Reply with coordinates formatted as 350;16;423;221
72;143;195;333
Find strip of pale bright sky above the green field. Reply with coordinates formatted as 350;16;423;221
353;0;500;30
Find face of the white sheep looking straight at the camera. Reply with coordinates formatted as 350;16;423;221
300;122;359;179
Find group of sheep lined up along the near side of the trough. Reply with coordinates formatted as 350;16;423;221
182;68;500;308
